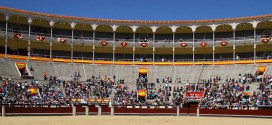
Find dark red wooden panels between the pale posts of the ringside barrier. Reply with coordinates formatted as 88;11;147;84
0;106;272;117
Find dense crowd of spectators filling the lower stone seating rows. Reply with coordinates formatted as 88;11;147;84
0;74;272;109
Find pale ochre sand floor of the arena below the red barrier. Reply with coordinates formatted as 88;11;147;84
0;116;272;125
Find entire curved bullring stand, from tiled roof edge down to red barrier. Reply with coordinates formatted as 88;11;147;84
0;7;272;117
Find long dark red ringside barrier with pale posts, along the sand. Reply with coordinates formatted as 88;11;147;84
1;105;272;117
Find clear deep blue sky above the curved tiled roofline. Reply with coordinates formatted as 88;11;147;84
0;0;272;20
